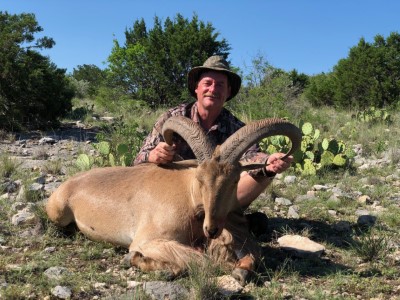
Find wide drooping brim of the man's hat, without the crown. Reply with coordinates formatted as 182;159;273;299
188;66;242;101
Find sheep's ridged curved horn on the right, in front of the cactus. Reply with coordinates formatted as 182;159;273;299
220;118;302;163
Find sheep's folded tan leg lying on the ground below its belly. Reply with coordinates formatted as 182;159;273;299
125;239;206;277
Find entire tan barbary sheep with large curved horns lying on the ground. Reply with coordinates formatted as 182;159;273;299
46;117;301;283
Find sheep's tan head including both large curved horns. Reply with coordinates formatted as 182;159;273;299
163;116;301;238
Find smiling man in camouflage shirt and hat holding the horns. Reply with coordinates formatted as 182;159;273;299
134;56;293;212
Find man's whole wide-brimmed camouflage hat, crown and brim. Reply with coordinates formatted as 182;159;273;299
188;55;242;101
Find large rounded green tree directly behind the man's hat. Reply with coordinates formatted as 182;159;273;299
108;14;230;108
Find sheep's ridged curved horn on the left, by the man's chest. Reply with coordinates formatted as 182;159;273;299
162;116;214;161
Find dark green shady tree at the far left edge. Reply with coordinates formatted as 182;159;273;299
0;11;74;130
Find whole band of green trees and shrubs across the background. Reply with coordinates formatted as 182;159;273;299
0;11;400;130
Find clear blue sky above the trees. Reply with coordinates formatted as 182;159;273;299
0;0;400;75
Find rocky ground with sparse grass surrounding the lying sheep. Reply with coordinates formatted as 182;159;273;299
0;111;400;299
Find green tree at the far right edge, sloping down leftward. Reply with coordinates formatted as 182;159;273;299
305;32;400;110
